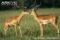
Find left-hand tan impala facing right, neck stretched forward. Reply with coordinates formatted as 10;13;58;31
3;11;29;36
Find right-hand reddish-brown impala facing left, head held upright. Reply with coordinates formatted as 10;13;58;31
31;8;59;36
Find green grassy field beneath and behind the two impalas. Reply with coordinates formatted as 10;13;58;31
0;8;60;40
